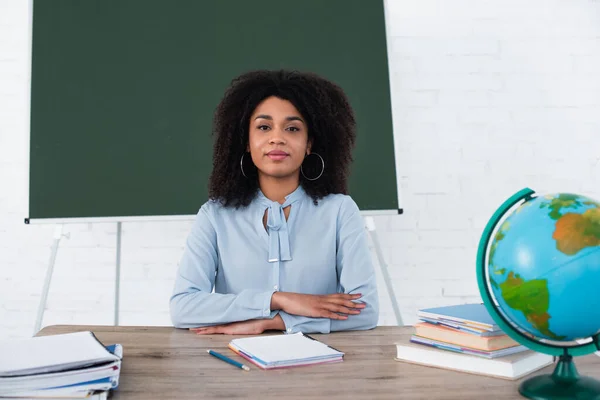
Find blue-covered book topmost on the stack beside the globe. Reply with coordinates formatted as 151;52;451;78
417;303;500;332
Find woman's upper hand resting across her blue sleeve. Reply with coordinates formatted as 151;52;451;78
271;292;366;319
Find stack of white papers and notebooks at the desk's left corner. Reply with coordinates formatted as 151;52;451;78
0;331;123;400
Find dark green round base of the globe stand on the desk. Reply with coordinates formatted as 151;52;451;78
519;350;600;400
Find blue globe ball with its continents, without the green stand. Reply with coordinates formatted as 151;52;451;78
488;193;600;341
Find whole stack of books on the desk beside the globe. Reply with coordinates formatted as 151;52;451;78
396;304;553;379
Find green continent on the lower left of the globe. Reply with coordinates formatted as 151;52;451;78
499;272;565;340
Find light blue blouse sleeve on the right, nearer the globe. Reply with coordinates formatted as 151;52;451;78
279;197;379;333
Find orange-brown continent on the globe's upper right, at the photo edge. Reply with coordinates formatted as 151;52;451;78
552;208;600;256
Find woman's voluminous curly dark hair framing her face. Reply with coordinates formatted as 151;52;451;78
208;70;356;208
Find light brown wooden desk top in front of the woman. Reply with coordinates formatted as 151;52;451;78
38;325;600;400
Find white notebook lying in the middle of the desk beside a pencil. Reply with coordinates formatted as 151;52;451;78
229;332;344;369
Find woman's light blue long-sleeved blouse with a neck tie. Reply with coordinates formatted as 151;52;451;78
170;186;379;333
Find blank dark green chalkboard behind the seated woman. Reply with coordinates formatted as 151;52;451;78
28;0;399;219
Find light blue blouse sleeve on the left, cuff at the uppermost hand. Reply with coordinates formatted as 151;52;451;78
170;203;276;328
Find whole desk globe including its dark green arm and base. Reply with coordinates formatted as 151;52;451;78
477;188;600;399
